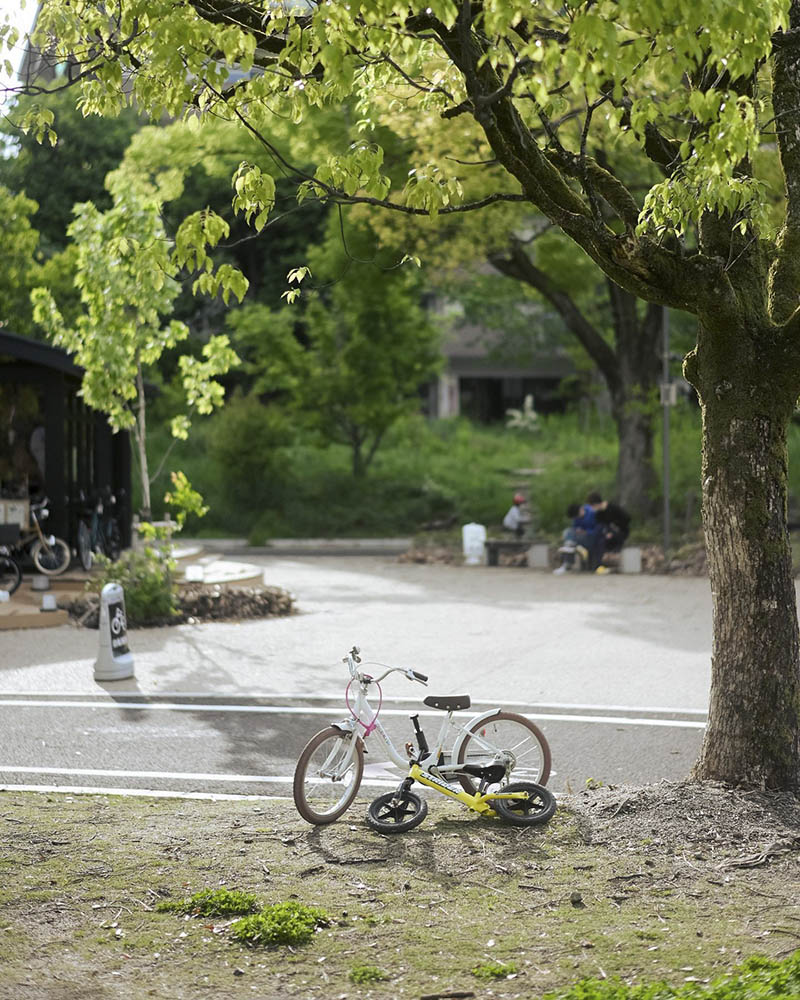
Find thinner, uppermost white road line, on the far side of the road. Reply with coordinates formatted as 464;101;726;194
0;691;708;716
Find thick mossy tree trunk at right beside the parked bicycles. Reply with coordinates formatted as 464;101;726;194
686;330;800;790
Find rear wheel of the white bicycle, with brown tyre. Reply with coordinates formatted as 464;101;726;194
456;712;552;795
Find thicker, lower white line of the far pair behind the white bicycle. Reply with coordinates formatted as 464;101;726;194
0;699;705;729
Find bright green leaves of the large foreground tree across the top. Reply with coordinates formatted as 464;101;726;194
17;0;789;270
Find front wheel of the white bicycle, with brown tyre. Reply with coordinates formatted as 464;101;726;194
292;726;364;826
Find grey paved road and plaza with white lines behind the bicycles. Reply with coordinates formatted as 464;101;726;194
0;557;710;795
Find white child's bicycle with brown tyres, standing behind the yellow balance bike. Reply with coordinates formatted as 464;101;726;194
293;646;551;832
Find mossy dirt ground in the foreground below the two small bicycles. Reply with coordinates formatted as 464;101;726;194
0;783;800;1000
